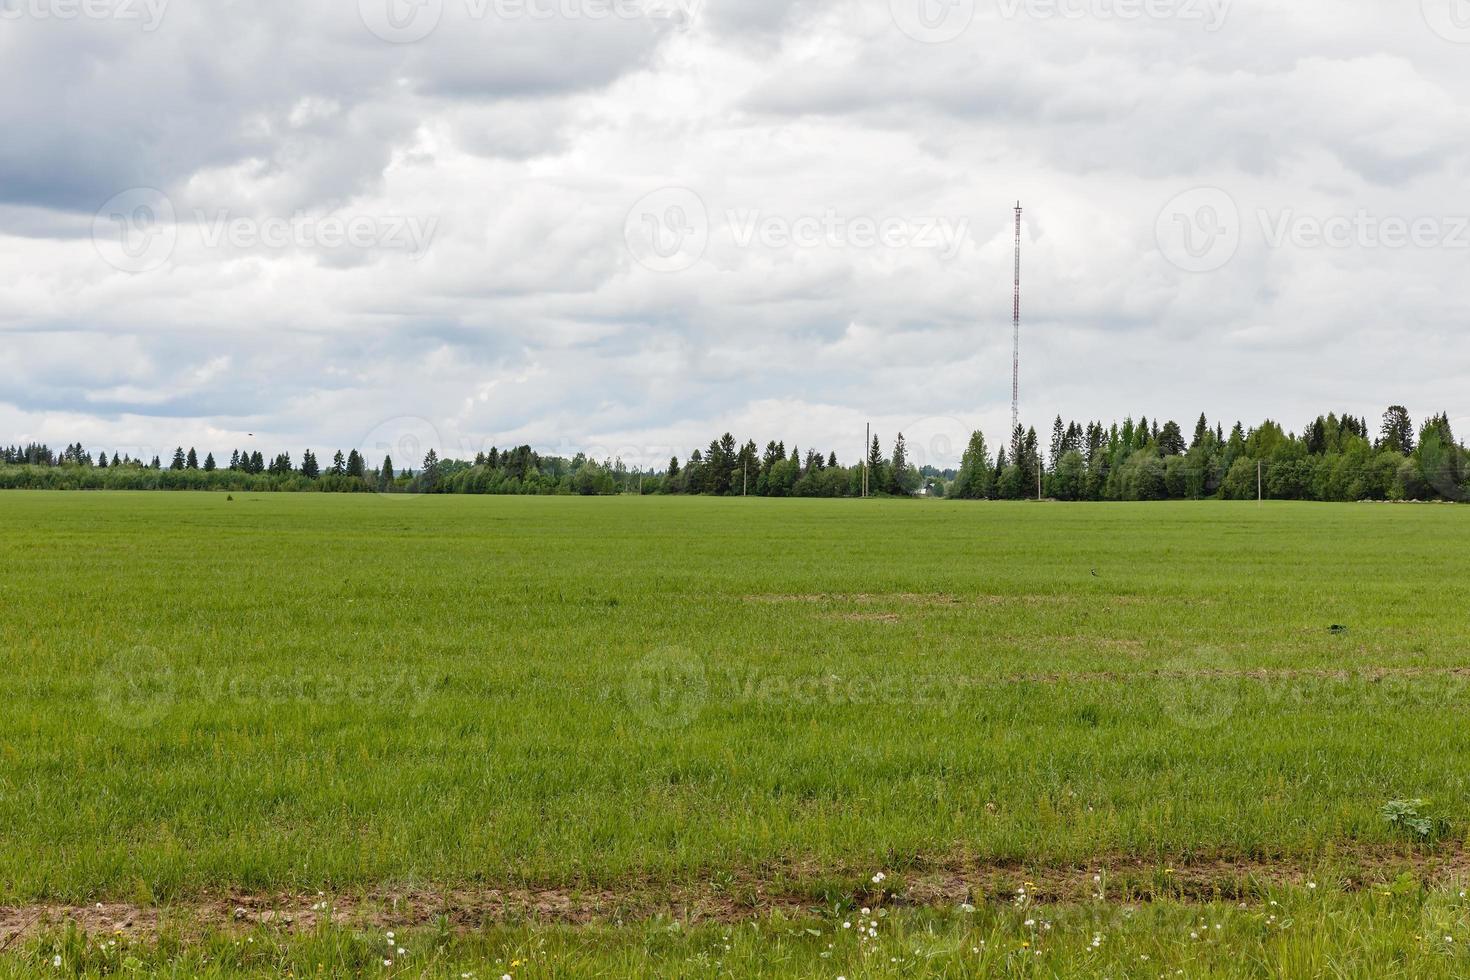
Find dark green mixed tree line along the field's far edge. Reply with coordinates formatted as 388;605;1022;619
0;406;1470;501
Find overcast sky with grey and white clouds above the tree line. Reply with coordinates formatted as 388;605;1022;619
0;0;1470;464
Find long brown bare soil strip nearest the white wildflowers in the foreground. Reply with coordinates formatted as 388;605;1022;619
0;846;1470;951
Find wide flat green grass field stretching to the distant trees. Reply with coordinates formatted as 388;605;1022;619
0;492;1470;976
